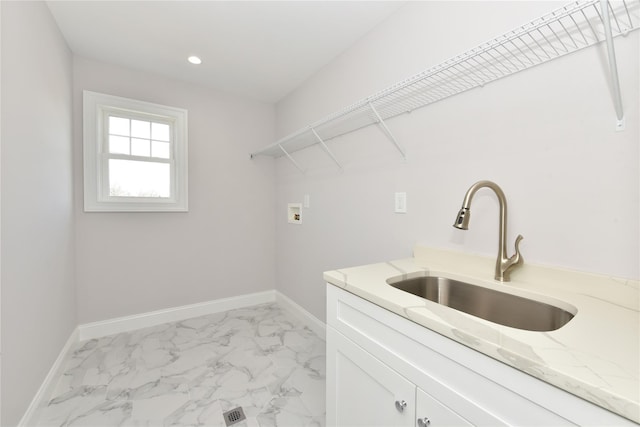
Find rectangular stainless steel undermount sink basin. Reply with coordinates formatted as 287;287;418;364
389;276;576;331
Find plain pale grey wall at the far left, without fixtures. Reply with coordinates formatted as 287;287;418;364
0;2;76;426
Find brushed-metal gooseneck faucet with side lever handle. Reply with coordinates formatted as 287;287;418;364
453;181;524;282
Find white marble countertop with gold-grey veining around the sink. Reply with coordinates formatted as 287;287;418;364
324;246;640;423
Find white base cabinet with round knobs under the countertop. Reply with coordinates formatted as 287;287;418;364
327;285;637;427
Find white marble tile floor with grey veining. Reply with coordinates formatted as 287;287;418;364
37;304;325;427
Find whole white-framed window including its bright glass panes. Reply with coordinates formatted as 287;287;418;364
83;91;188;212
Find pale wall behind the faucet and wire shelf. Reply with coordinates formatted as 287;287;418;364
276;2;640;318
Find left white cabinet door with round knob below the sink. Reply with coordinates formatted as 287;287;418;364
327;327;416;427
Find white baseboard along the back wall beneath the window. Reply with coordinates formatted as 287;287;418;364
78;290;276;341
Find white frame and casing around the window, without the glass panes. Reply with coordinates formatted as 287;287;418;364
83;90;188;212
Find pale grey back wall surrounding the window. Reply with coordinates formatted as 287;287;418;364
74;57;275;323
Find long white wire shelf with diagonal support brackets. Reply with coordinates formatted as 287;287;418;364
251;0;640;169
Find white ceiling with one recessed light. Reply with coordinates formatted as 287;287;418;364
47;1;403;103
